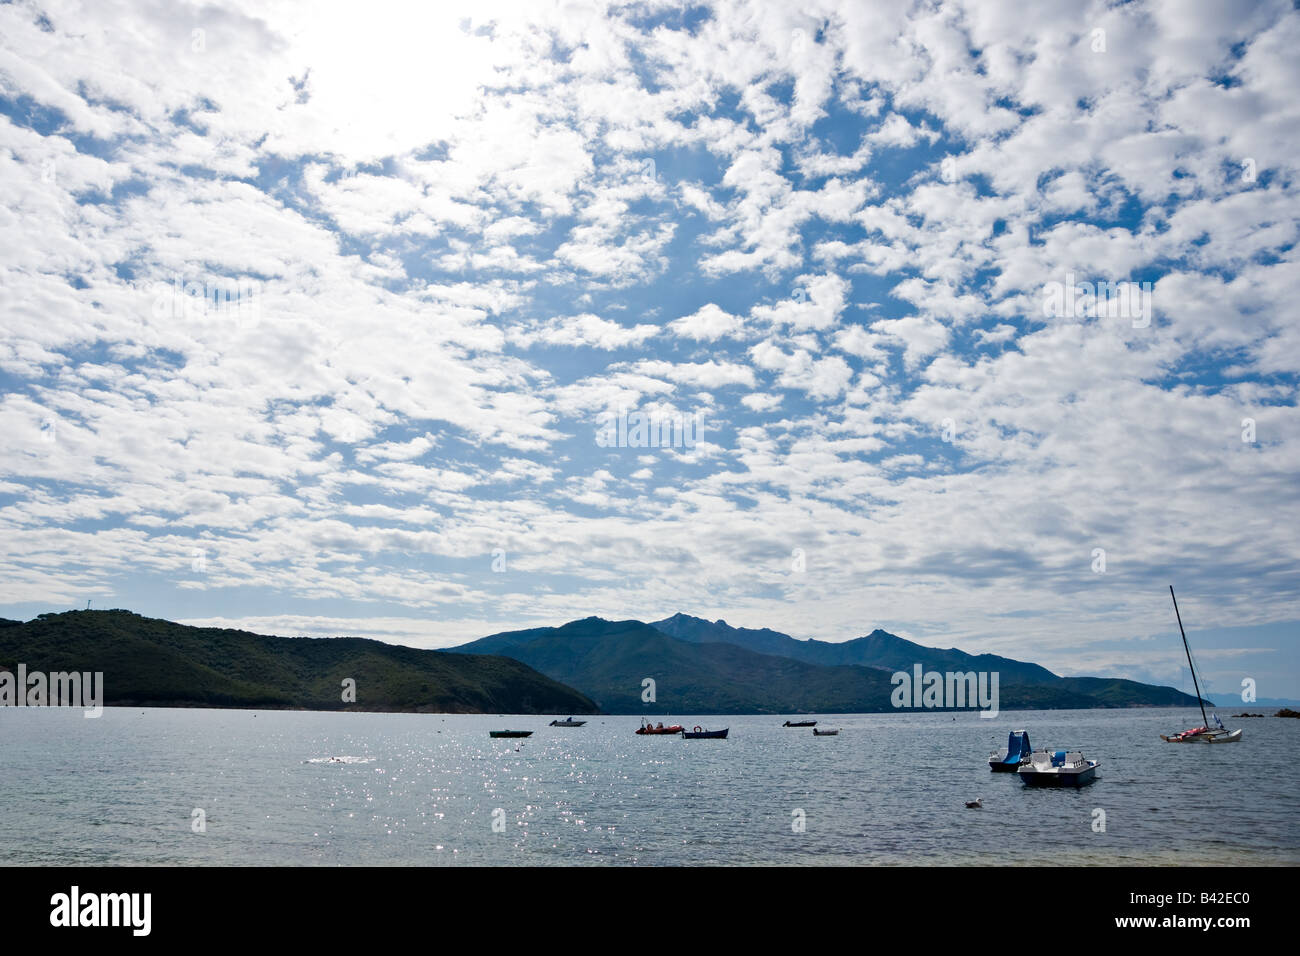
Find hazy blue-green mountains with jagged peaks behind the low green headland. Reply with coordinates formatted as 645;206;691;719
451;614;1196;714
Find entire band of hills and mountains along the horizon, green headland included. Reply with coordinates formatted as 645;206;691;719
0;610;1196;715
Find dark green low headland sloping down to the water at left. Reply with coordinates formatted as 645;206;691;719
0;610;597;714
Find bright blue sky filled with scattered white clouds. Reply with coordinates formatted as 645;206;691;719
0;0;1300;697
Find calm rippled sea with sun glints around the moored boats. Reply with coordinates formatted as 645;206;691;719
0;708;1300;865
